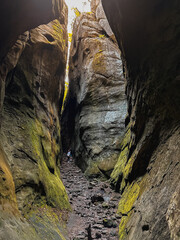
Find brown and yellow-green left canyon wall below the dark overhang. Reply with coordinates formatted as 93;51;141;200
0;1;70;240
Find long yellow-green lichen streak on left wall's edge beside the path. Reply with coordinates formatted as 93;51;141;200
31;119;70;209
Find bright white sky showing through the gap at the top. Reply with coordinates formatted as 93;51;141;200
65;0;91;33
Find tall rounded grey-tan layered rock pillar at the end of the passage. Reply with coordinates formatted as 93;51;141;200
62;1;127;176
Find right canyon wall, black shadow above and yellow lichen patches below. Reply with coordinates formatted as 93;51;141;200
102;0;180;240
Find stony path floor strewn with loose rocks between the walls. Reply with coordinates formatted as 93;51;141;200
61;159;120;240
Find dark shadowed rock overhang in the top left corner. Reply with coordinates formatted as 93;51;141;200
0;0;64;61
